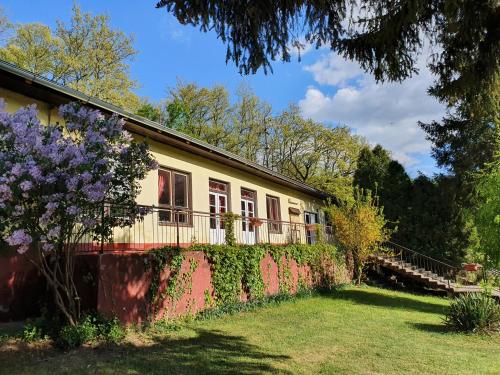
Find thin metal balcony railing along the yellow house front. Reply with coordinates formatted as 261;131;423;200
78;206;334;252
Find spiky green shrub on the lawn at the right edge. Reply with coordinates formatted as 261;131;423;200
445;293;500;332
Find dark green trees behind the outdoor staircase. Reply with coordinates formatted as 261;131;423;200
354;146;476;263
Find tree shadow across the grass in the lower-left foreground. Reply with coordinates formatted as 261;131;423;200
0;329;290;375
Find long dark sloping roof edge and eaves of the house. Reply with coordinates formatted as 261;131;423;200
0;60;328;198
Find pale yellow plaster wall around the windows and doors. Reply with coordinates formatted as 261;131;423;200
0;88;323;247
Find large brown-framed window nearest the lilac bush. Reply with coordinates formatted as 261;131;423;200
158;168;191;224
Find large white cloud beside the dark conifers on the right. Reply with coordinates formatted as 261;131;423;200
299;53;445;176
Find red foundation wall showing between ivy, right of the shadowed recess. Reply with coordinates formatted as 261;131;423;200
97;251;312;323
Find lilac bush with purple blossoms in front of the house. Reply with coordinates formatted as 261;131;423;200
0;99;156;324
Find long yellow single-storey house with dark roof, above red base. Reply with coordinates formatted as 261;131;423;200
0;61;329;251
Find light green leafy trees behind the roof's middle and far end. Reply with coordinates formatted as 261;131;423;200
163;82;365;199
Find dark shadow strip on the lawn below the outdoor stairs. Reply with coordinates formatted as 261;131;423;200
328;289;446;314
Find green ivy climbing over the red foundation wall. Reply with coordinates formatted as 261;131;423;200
147;244;350;311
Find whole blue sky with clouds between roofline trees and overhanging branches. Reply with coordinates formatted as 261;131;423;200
2;0;444;176
